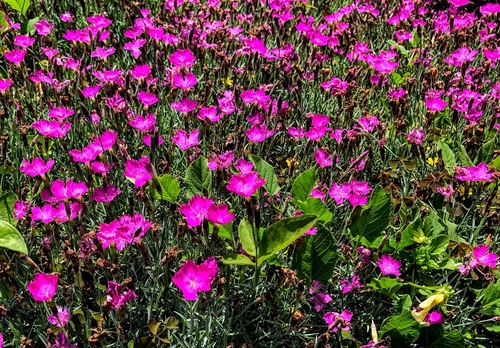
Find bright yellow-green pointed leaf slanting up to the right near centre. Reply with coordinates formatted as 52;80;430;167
258;214;317;265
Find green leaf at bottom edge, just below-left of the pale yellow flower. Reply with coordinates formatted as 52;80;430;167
380;311;420;347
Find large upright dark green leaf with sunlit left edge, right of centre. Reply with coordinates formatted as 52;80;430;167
349;187;392;247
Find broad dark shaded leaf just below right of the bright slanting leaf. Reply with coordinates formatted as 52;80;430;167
292;225;337;285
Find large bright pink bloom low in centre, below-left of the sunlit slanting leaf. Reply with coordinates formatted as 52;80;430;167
172;256;218;301
